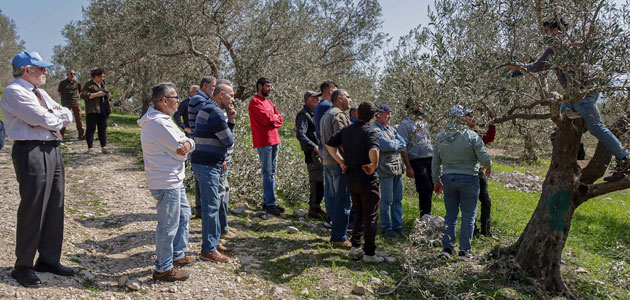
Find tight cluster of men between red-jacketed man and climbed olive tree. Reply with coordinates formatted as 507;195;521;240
296;81;495;262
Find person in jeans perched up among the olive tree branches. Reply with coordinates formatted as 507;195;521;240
507;18;630;182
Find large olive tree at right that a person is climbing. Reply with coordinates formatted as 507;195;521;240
384;0;630;294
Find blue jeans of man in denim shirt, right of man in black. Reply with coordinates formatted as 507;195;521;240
379;175;403;232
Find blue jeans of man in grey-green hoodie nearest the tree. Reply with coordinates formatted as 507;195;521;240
442;174;479;250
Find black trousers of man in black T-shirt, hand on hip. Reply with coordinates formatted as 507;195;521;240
347;180;381;255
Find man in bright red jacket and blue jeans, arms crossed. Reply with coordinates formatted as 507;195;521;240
248;77;284;216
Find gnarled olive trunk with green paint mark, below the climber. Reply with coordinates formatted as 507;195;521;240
516;118;587;296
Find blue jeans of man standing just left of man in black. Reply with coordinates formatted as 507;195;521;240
324;165;352;242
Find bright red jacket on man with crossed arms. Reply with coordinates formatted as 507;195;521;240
248;95;283;148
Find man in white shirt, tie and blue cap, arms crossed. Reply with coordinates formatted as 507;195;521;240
0;51;74;287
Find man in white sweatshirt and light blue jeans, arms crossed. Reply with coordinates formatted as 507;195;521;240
138;82;195;281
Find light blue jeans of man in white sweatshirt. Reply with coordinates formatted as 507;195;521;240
151;185;190;272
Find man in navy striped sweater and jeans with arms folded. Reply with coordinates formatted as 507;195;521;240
191;84;236;262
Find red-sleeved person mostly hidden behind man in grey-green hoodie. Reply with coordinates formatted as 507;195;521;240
464;109;496;236
